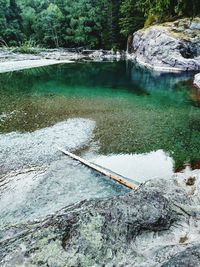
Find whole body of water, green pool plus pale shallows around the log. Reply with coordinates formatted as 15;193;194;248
0;62;200;228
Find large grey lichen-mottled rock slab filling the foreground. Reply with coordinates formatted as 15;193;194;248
0;170;200;267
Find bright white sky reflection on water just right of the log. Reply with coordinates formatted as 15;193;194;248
91;150;174;182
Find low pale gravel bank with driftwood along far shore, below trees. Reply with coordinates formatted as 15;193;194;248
0;48;125;73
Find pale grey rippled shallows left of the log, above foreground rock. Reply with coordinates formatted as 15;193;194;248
0;118;128;228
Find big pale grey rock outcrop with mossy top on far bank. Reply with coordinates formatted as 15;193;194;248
130;18;200;71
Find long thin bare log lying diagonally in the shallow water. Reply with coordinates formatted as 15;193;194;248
58;147;138;189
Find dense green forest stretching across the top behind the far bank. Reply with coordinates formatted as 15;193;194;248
0;0;200;49
